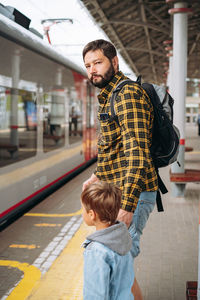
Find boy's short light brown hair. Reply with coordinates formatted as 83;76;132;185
81;181;121;225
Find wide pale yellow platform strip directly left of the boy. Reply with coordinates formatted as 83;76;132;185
27;224;93;300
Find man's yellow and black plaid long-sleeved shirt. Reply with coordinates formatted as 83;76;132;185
95;71;158;212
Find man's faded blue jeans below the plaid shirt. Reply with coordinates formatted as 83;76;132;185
129;192;157;258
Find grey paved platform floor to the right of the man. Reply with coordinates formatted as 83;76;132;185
135;126;200;300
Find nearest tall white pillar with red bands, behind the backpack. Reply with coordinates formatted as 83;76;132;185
167;0;191;197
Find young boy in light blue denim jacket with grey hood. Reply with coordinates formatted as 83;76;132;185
81;181;134;300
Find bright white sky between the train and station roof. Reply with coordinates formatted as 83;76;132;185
0;0;135;79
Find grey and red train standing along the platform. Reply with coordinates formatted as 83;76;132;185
0;10;98;228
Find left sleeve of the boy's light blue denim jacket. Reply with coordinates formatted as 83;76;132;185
83;250;110;300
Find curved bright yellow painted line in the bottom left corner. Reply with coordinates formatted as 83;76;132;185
0;260;41;300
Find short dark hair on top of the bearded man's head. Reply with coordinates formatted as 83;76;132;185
83;39;117;61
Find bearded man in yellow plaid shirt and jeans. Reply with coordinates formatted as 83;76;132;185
83;40;158;300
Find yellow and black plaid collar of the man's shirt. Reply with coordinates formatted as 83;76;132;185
98;71;127;103
